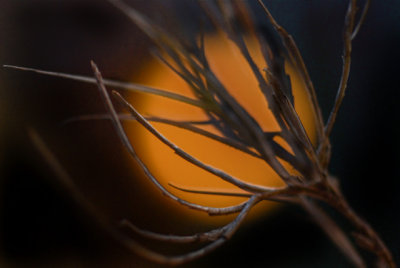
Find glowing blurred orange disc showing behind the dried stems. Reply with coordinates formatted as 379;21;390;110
126;36;314;223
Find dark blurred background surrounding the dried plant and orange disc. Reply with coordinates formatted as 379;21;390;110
0;0;400;267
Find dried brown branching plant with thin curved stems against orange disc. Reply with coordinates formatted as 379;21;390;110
3;0;396;267
